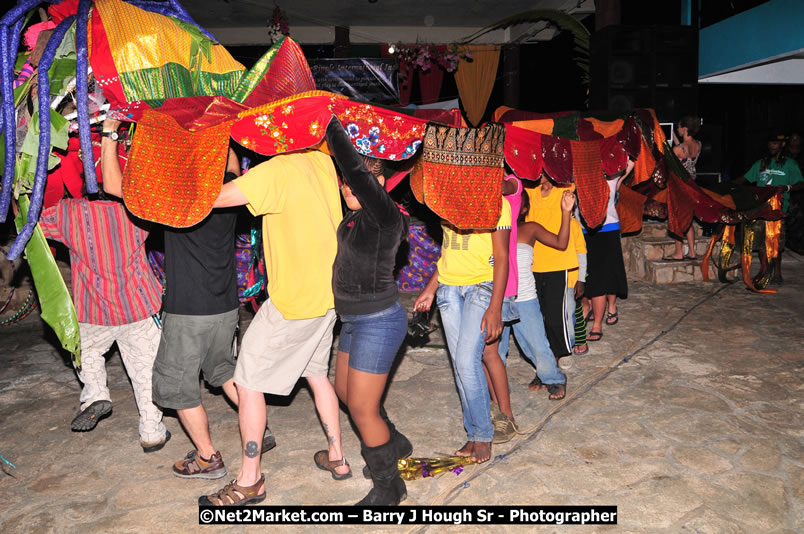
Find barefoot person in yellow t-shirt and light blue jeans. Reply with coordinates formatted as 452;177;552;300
414;202;511;462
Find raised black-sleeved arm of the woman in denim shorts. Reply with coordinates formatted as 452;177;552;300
327;117;399;224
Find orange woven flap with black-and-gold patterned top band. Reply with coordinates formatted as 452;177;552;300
418;124;505;229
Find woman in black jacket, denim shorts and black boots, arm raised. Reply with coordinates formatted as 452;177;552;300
322;117;412;506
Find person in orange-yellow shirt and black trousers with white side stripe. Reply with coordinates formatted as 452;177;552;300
525;174;578;359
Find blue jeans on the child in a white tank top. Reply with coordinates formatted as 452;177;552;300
498;299;567;384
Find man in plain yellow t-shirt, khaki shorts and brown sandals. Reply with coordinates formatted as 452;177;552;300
198;150;350;506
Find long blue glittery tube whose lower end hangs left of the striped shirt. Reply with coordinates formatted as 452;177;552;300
6;15;75;261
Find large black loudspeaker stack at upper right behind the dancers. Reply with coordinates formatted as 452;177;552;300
590;25;698;122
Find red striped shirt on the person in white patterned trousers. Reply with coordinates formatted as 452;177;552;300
39;198;162;326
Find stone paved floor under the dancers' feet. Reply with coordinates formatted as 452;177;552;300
0;255;804;534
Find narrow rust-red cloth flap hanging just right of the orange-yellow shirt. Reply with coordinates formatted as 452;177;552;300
569;141;609;228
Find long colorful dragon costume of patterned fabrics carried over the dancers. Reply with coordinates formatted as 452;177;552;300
0;0;778;364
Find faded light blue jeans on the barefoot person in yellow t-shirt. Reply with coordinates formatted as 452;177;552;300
436;282;494;442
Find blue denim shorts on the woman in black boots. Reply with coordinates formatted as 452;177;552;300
338;300;408;374
